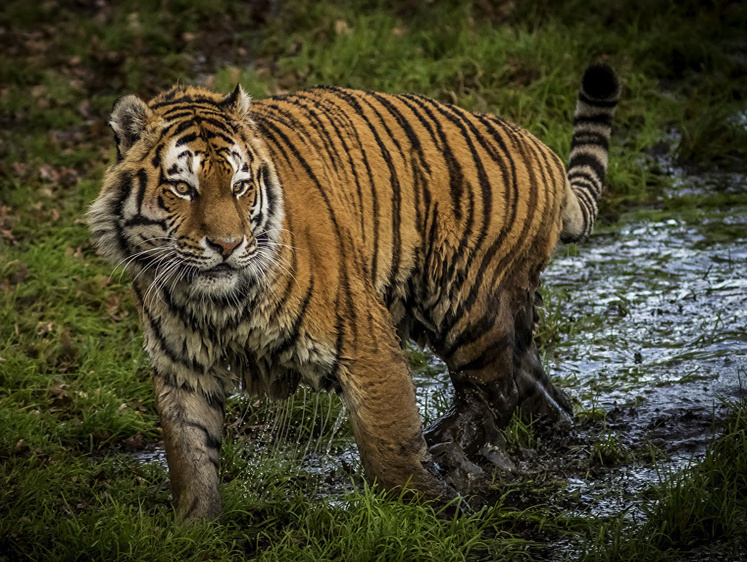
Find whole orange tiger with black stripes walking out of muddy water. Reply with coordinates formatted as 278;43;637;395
88;64;620;521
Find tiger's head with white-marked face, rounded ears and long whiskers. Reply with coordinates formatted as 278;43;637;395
88;86;283;298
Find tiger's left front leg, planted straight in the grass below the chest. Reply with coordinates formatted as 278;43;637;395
154;373;224;520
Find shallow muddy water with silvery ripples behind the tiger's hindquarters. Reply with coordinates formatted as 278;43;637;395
524;176;747;518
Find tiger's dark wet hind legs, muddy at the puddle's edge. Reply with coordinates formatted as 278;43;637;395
425;288;571;491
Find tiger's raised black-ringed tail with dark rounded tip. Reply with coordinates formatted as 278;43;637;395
560;64;620;242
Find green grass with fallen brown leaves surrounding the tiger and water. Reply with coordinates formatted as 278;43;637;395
0;0;747;560
